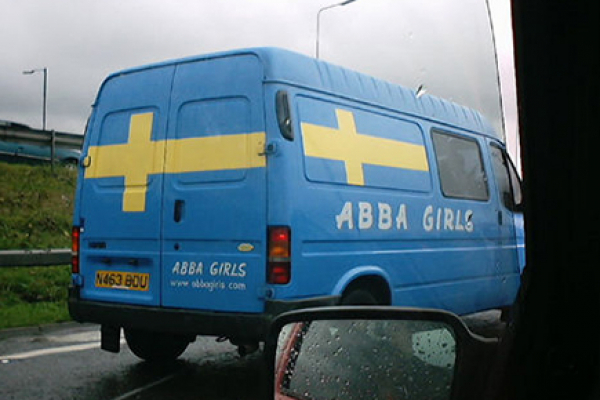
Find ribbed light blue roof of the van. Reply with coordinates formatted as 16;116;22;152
107;47;504;141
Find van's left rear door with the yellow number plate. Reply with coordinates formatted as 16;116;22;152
75;66;174;305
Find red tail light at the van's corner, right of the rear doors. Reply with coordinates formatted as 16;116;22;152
267;226;292;285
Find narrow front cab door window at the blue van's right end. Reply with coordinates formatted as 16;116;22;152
490;144;522;211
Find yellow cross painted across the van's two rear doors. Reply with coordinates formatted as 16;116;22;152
84;112;266;212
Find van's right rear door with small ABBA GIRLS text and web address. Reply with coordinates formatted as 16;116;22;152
162;55;267;312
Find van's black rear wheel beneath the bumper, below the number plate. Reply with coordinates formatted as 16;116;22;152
125;329;190;362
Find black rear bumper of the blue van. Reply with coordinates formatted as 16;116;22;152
69;288;339;341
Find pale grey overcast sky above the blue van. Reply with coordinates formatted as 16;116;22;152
0;0;516;158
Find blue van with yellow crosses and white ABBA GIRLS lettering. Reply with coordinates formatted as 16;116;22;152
69;48;522;360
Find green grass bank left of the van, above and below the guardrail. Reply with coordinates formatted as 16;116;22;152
0;162;77;329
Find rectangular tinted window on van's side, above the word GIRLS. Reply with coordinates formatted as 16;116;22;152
431;130;489;201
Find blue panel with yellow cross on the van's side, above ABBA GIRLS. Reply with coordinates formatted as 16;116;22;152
300;99;431;192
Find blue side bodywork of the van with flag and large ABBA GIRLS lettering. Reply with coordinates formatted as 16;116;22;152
271;92;518;313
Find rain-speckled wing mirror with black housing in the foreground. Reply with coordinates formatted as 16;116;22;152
265;307;497;400
